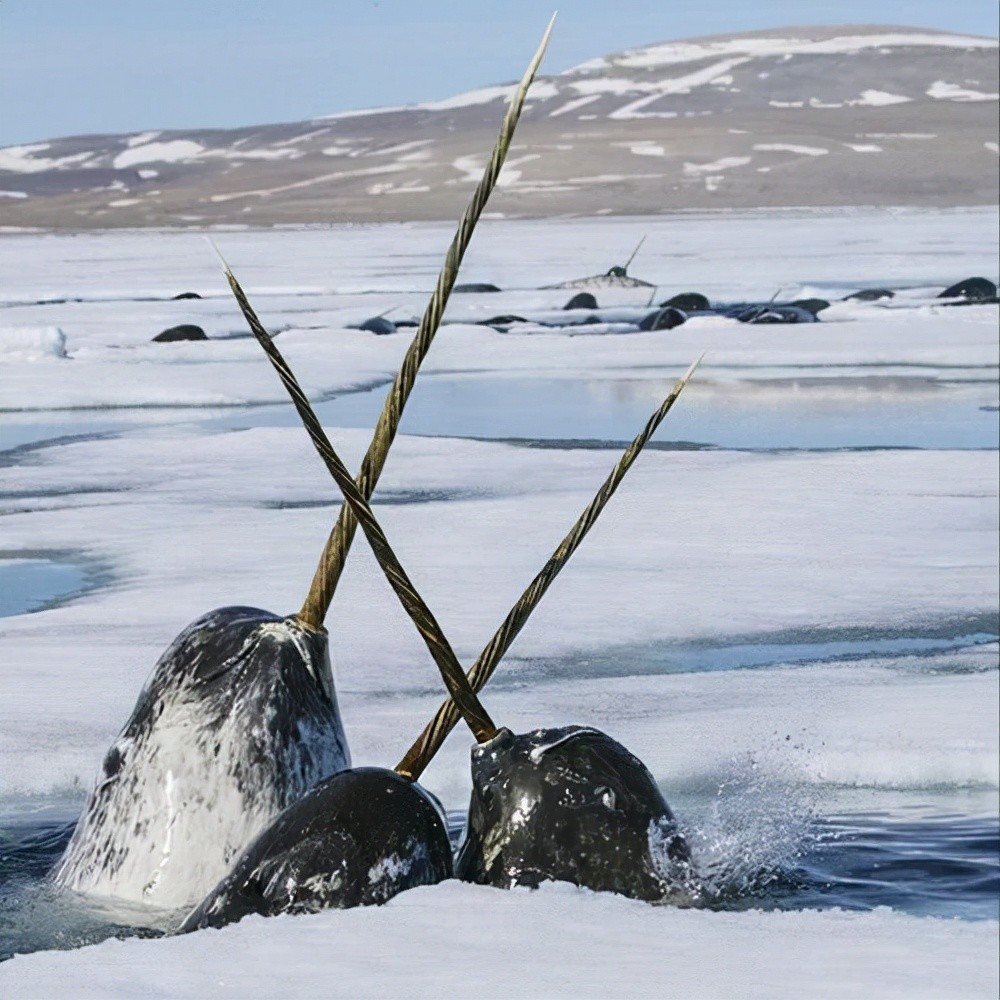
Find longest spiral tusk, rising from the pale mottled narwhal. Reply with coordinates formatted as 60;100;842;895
298;14;555;627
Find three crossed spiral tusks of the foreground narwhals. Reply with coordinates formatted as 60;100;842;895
209;15;704;781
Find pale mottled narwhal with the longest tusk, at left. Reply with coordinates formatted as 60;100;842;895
53;17;552;907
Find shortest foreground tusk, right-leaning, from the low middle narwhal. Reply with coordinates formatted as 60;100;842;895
396;354;705;781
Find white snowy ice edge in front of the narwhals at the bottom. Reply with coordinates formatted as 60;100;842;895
0;882;996;1000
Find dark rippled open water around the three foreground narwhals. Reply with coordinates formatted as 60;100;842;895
0;810;1000;961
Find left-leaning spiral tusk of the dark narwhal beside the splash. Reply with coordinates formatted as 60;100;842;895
216;248;498;743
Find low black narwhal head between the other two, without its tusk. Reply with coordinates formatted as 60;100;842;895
180;767;452;932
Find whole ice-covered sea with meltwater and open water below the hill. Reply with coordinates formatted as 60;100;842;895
0;209;1000;998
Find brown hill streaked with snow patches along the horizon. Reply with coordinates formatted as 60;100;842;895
0;26;1000;228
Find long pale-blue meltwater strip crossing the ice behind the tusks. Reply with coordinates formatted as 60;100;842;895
0;373;1000;452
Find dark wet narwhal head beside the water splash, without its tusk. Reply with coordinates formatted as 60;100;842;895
456;726;689;900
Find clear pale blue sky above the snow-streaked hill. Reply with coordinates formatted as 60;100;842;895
0;0;998;146
